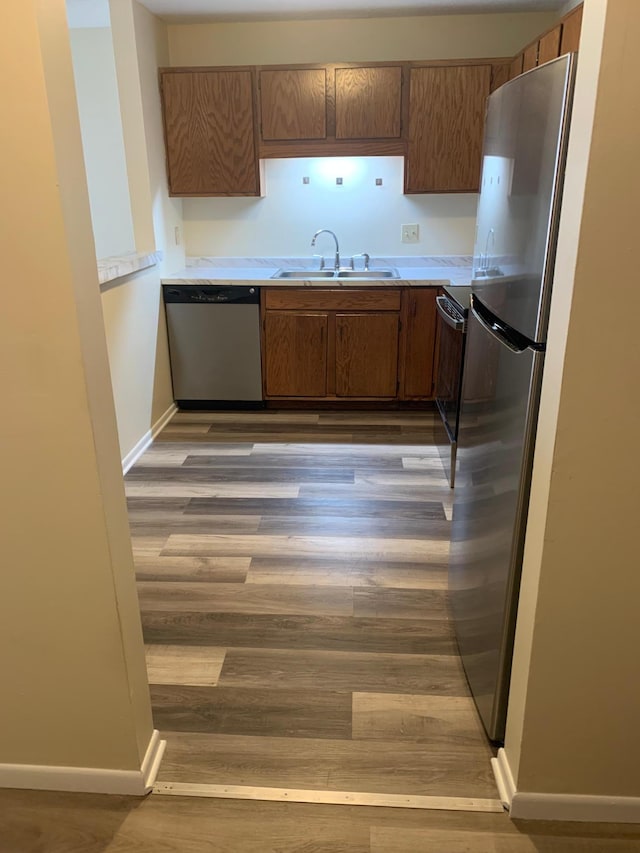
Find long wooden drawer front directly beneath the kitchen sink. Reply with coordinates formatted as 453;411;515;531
264;287;401;311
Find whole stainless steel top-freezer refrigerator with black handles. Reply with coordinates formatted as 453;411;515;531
449;55;575;741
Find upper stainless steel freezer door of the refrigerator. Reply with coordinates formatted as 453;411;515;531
472;55;573;342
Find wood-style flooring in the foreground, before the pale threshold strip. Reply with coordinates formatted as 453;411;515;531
0;790;640;853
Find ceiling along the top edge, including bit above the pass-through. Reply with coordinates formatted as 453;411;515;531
67;0;567;27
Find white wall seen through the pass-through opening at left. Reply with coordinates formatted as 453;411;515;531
70;27;135;258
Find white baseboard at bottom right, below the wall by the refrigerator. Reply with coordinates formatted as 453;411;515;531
491;749;640;823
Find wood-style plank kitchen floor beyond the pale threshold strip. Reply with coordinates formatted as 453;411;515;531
126;412;498;800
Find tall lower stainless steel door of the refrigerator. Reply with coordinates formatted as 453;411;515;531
449;311;543;741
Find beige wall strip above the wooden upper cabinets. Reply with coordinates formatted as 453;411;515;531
169;12;557;65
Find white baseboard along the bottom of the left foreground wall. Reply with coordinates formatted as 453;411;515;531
0;729;166;797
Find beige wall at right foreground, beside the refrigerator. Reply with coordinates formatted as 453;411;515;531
505;0;640;797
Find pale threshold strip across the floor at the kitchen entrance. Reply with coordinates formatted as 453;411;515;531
153;782;503;813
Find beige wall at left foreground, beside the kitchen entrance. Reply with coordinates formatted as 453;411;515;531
0;0;152;770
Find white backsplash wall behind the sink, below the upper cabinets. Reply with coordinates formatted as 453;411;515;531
184;157;477;257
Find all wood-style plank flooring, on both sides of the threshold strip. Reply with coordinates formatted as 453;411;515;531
5;413;640;853
